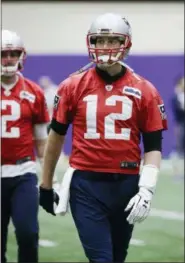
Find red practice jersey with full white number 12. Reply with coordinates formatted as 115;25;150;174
53;69;167;174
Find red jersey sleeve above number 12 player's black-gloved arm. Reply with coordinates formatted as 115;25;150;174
52;81;74;124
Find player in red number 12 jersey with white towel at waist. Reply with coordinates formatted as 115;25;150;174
40;14;167;262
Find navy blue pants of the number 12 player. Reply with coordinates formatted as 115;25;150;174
70;170;139;262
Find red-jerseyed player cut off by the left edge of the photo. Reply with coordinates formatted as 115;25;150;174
1;30;49;262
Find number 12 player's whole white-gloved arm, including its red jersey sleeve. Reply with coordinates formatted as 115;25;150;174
125;83;167;224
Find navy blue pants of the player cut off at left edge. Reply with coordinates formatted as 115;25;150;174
1;173;39;262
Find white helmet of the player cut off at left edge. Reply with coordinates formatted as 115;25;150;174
1;30;26;76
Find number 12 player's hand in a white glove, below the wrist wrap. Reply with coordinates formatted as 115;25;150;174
125;187;153;224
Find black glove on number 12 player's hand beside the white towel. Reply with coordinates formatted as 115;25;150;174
39;186;59;216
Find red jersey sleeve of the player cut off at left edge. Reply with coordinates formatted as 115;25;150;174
34;88;50;124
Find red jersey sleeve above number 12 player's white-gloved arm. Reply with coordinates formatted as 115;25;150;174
140;84;168;132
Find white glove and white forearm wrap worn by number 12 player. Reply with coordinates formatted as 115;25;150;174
125;164;159;224
